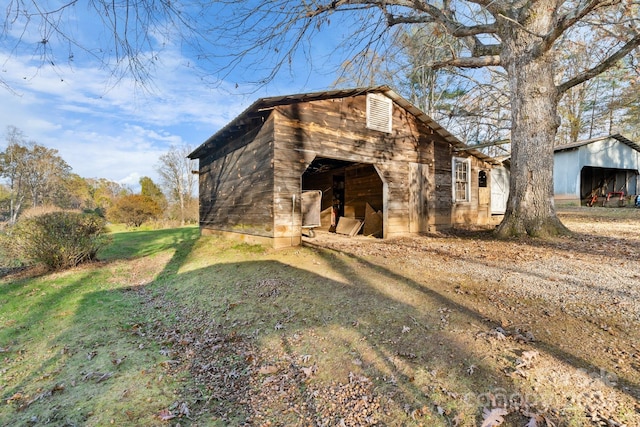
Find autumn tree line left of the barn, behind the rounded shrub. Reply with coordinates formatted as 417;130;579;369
0;126;198;227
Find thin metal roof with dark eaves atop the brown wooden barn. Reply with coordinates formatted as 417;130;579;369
188;85;499;164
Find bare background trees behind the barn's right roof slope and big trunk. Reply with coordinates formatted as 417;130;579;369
344;24;640;157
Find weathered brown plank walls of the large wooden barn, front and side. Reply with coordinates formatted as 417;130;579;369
199;90;490;247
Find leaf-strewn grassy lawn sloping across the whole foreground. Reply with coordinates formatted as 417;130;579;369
0;211;640;427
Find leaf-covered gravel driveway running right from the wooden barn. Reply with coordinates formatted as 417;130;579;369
300;208;640;426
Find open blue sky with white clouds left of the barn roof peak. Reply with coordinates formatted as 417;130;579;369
0;2;350;189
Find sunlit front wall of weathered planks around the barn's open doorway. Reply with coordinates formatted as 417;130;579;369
274;95;444;237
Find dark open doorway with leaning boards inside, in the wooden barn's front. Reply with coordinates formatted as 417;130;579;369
302;157;384;238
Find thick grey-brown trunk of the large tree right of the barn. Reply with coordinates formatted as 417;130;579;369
497;8;569;237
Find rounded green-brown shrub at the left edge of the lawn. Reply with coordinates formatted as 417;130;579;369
10;211;108;270
